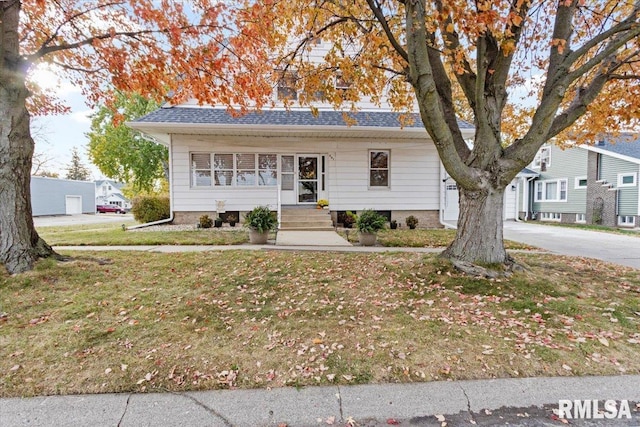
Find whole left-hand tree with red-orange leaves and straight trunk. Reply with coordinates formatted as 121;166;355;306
0;0;276;273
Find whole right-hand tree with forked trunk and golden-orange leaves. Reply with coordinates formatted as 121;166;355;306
268;0;640;271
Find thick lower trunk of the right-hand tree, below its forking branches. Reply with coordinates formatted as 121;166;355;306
442;188;510;265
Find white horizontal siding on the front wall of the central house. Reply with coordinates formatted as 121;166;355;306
171;135;441;212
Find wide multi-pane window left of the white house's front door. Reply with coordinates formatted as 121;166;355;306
191;153;278;187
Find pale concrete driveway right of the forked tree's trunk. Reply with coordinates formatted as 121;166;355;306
504;221;640;269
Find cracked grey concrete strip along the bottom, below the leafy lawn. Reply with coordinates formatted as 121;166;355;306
0;375;640;427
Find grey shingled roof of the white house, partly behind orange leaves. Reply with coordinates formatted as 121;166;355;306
134;107;473;129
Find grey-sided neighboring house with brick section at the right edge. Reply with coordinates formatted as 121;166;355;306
521;134;640;227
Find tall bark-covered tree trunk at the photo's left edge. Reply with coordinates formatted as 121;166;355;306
0;2;56;273
